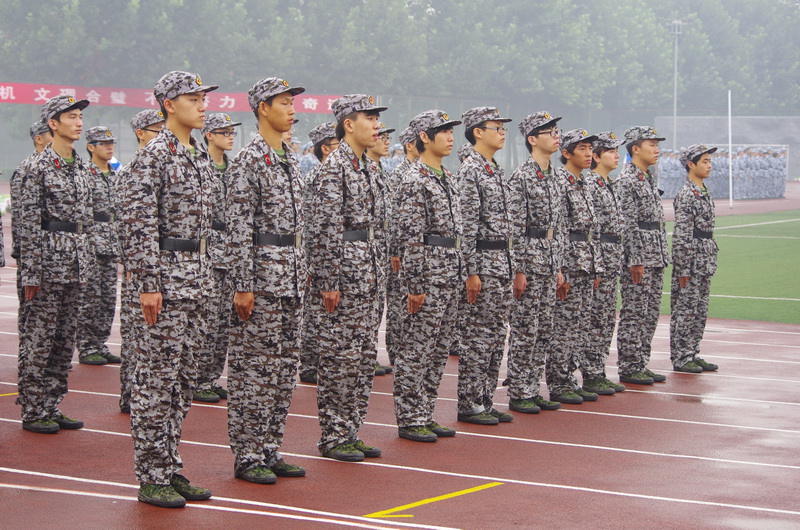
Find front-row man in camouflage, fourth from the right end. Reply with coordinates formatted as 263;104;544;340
545;129;603;404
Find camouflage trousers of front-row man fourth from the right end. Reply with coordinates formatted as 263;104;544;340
545;272;594;396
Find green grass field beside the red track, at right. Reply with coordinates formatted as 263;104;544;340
661;210;800;324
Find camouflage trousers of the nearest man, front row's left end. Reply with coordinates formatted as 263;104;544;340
131;300;207;485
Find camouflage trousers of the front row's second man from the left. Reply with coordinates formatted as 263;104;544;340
228;292;303;473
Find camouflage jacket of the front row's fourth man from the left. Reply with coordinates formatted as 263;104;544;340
395;162;466;294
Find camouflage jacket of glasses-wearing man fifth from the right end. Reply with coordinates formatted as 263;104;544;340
509;157;563;275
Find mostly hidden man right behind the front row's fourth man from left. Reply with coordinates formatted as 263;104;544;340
385;127;419;365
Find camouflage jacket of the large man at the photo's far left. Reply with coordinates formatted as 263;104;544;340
17;145;95;286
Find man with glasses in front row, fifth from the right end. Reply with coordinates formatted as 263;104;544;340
503;111;563;414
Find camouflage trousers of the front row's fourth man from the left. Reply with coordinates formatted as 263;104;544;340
394;285;456;427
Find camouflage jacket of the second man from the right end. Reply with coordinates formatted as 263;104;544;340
614;163;669;268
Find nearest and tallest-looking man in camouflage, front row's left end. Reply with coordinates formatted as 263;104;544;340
120;71;218;508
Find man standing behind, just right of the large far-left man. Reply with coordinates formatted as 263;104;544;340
75;127;121;365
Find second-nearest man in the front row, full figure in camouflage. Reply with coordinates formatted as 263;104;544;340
226;77;308;484
